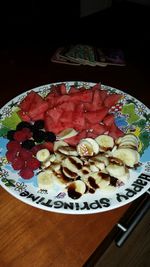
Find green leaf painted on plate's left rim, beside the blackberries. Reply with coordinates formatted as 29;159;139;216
1;111;21;130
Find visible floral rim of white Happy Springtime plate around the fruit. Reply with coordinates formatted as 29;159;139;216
0;82;150;214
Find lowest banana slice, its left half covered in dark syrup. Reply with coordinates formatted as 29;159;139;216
67;180;86;199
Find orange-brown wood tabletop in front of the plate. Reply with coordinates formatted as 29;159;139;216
0;188;129;267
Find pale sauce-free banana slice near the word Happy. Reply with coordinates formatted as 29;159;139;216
106;164;129;179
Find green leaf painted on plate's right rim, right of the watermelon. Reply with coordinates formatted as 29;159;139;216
122;103;140;124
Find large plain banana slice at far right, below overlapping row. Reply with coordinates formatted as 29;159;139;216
113;148;140;168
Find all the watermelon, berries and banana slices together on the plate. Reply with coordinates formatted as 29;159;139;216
6;84;139;199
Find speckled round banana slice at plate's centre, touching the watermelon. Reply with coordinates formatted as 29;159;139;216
77;139;94;157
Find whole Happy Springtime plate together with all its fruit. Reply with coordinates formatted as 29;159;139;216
0;81;150;214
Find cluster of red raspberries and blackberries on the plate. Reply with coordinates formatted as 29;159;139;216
6;120;56;179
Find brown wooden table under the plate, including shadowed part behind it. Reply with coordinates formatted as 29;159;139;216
0;48;150;267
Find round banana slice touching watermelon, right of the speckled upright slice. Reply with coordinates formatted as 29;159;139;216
95;134;114;151
